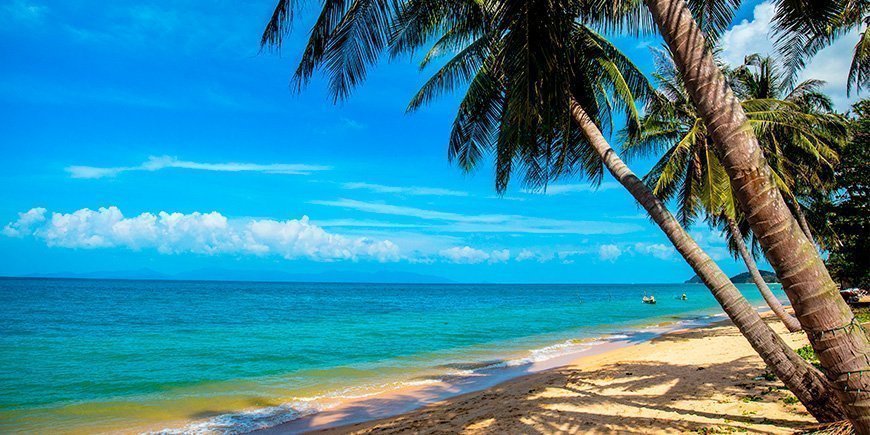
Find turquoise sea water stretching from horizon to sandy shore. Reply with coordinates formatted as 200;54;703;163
0;279;782;433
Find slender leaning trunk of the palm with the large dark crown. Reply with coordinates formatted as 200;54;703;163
571;99;844;422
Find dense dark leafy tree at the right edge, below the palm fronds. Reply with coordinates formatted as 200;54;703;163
826;99;870;289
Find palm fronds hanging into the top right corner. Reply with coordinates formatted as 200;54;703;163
773;0;870;95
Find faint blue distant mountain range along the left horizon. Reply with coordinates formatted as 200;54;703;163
13;268;453;284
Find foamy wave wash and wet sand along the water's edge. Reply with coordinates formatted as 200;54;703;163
145;307;736;435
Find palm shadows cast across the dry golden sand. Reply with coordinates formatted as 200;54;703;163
292;358;807;434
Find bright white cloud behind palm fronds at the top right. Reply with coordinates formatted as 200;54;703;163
720;0;859;110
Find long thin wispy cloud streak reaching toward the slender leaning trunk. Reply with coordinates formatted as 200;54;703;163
311;199;643;234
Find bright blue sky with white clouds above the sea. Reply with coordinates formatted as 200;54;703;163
0;0;856;283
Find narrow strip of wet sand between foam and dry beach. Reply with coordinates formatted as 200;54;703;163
251;314;729;435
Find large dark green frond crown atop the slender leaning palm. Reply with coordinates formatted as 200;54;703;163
263;0;652;192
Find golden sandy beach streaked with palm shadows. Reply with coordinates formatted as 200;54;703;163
263;316;814;434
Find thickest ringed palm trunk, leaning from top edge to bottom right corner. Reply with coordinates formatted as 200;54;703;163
646;0;870;434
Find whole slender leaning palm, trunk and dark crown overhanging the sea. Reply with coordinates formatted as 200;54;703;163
264;0;843;421
